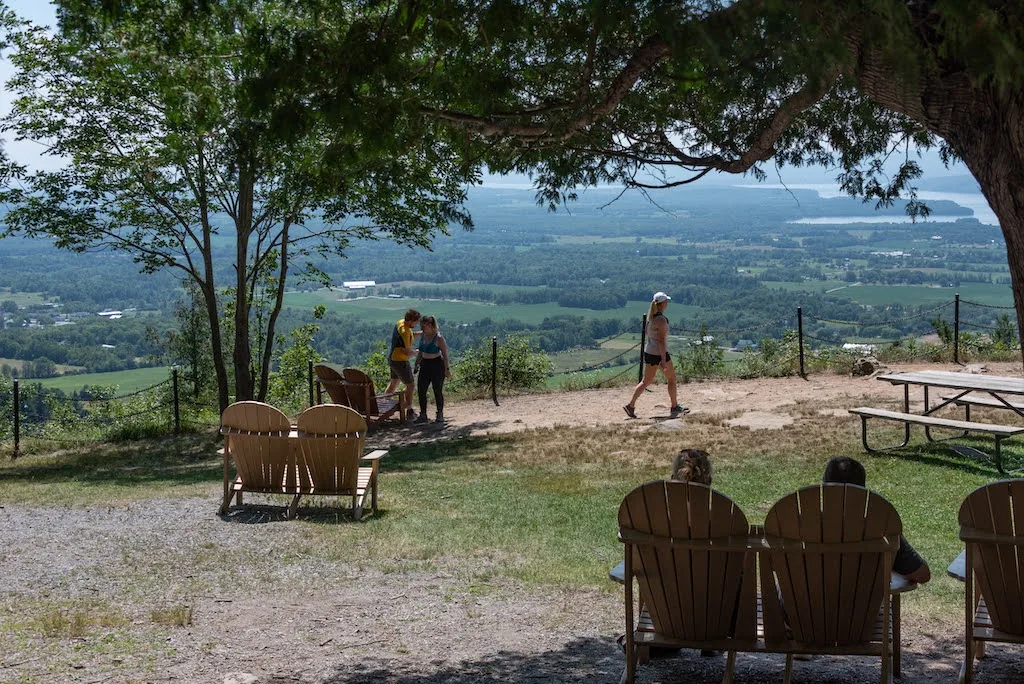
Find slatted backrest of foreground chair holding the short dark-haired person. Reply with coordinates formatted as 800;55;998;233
761;484;903;647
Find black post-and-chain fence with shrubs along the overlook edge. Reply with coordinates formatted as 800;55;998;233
0;295;1021;450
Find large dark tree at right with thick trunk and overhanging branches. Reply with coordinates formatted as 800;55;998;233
413;0;1024;352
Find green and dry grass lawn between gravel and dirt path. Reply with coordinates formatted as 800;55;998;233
0;397;1011;619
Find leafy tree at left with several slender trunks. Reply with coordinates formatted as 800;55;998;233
0;0;475;408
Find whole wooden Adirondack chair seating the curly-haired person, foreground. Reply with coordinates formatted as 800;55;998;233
618;481;757;683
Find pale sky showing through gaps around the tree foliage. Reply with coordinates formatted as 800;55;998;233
0;0;969;192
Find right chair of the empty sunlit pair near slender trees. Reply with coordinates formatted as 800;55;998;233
290;403;387;520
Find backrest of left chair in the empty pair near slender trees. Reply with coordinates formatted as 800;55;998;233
220;401;295;489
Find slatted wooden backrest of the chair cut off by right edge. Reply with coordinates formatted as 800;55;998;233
959;480;1024;635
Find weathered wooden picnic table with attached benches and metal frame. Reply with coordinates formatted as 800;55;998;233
850;371;1024;473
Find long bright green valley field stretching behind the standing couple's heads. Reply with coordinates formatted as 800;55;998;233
285;290;700;326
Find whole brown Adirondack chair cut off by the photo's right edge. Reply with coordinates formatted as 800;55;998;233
959;480;1024;683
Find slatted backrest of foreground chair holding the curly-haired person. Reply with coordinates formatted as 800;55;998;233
618;480;755;641
